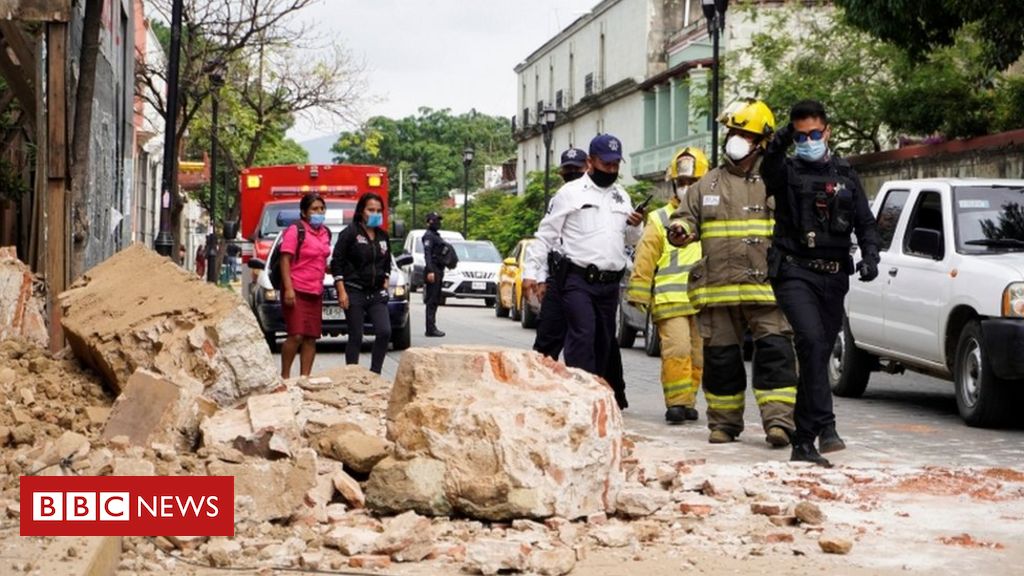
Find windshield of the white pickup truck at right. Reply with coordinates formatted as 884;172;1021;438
953;186;1024;253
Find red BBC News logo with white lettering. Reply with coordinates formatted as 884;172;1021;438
20;476;234;536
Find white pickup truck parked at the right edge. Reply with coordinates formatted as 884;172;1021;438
829;178;1024;426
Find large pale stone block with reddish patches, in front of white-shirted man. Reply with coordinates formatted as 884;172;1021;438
367;346;624;520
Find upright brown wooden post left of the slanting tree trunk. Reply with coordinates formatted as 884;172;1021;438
45;24;71;352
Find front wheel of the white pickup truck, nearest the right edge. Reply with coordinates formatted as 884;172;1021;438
953;320;1013;427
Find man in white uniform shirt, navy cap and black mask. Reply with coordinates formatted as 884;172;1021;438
523;134;643;404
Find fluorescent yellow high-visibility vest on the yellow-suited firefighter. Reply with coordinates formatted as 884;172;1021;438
649;204;701;321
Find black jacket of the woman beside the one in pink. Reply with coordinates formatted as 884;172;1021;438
331;222;391;291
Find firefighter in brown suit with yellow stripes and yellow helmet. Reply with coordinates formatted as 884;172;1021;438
669;100;797;448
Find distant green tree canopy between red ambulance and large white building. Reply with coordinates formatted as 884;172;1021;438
331;108;515;206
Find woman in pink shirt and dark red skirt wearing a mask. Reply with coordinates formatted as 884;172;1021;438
280;193;331;379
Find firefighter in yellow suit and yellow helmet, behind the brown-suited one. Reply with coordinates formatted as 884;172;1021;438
626;147;708;424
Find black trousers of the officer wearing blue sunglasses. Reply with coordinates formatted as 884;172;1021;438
772;262;850;442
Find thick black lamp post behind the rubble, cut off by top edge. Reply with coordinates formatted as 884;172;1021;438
153;0;183;257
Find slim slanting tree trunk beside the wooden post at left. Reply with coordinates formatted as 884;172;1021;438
71;0;103;279
